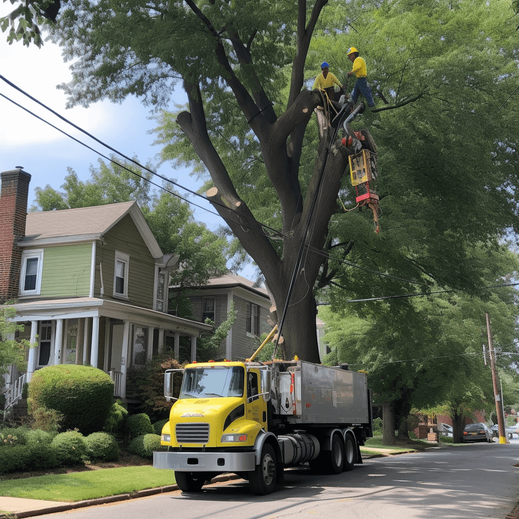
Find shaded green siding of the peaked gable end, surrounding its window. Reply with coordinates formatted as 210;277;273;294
95;215;155;308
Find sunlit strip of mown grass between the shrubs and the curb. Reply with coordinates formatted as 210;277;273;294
0;465;175;502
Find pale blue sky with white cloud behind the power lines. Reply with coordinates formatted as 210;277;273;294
0;7;222;230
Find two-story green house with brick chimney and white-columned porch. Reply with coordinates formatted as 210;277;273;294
0;169;212;412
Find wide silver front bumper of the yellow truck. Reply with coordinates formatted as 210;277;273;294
153;451;256;472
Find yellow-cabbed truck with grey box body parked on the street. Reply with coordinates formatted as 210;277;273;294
153;360;372;495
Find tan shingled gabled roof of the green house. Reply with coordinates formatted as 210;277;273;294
18;202;162;258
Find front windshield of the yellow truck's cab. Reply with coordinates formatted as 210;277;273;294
179;366;244;398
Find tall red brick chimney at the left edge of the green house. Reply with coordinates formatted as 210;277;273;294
0;167;31;304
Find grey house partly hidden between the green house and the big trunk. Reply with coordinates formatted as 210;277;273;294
186;274;272;360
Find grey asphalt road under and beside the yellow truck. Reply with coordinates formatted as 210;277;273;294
45;439;519;519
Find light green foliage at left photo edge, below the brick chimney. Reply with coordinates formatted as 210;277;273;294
0;303;35;374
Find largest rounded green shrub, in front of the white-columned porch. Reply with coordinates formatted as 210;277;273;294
28;364;113;434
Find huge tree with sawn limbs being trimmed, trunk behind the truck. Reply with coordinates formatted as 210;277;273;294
1;0;519;360
